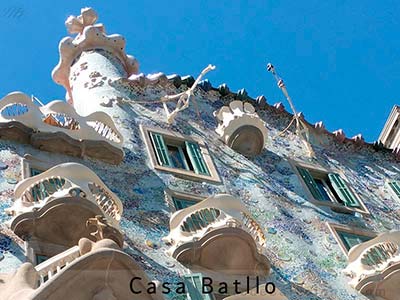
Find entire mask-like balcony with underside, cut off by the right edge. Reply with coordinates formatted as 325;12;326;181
344;231;400;300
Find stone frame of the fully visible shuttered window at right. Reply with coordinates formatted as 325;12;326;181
288;159;370;215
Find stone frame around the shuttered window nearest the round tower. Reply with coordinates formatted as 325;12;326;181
140;125;221;183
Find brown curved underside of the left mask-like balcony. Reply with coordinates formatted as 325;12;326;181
10;197;115;247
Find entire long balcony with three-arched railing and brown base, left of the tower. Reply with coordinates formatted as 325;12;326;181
0;92;124;164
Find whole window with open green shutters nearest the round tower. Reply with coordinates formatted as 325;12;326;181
141;126;220;182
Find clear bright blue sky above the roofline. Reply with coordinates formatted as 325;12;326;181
0;0;400;141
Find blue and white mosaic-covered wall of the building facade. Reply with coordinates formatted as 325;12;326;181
0;36;400;300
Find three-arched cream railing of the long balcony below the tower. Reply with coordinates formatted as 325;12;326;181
0;92;123;149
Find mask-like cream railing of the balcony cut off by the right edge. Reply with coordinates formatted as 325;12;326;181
344;231;400;287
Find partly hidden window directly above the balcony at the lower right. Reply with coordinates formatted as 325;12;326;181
328;223;377;255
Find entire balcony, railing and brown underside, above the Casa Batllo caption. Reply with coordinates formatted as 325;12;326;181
164;194;270;277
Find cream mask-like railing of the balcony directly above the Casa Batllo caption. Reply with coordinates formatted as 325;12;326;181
164;194;266;252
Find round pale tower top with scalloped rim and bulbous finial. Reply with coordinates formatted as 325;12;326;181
52;8;139;115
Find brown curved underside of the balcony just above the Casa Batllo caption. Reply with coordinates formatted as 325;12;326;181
172;227;271;276
